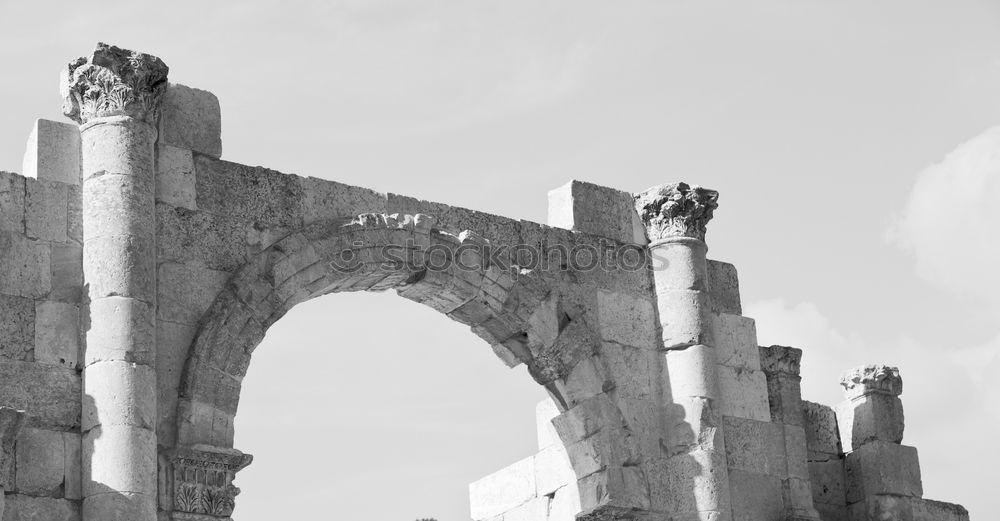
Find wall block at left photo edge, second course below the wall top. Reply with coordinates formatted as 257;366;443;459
0;231;52;298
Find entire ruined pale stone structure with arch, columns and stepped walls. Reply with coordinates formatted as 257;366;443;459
0;44;968;521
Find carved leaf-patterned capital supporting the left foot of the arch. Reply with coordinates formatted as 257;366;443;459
164;445;253;520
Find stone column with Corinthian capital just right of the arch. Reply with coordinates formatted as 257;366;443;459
635;183;731;520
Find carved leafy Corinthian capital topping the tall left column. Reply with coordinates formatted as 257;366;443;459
60;43;169;125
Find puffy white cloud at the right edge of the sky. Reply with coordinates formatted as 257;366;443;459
889;127;1000;305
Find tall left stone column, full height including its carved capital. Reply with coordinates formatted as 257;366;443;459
62;44;167;521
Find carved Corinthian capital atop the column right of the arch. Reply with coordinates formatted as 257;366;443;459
635;183;719;242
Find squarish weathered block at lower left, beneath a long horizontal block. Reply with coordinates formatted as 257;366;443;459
15;429;66;497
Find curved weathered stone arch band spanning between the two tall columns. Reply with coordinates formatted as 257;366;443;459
173;214;644;511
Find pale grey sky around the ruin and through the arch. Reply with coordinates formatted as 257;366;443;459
0;0;1000;521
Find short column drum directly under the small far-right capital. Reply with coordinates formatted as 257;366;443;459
837;393;904;452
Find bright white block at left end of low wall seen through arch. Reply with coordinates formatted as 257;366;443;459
469;457;535;520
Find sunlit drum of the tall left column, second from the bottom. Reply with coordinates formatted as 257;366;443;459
81;426;157;497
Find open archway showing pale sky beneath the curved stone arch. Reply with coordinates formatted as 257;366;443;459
233;293;546;521
